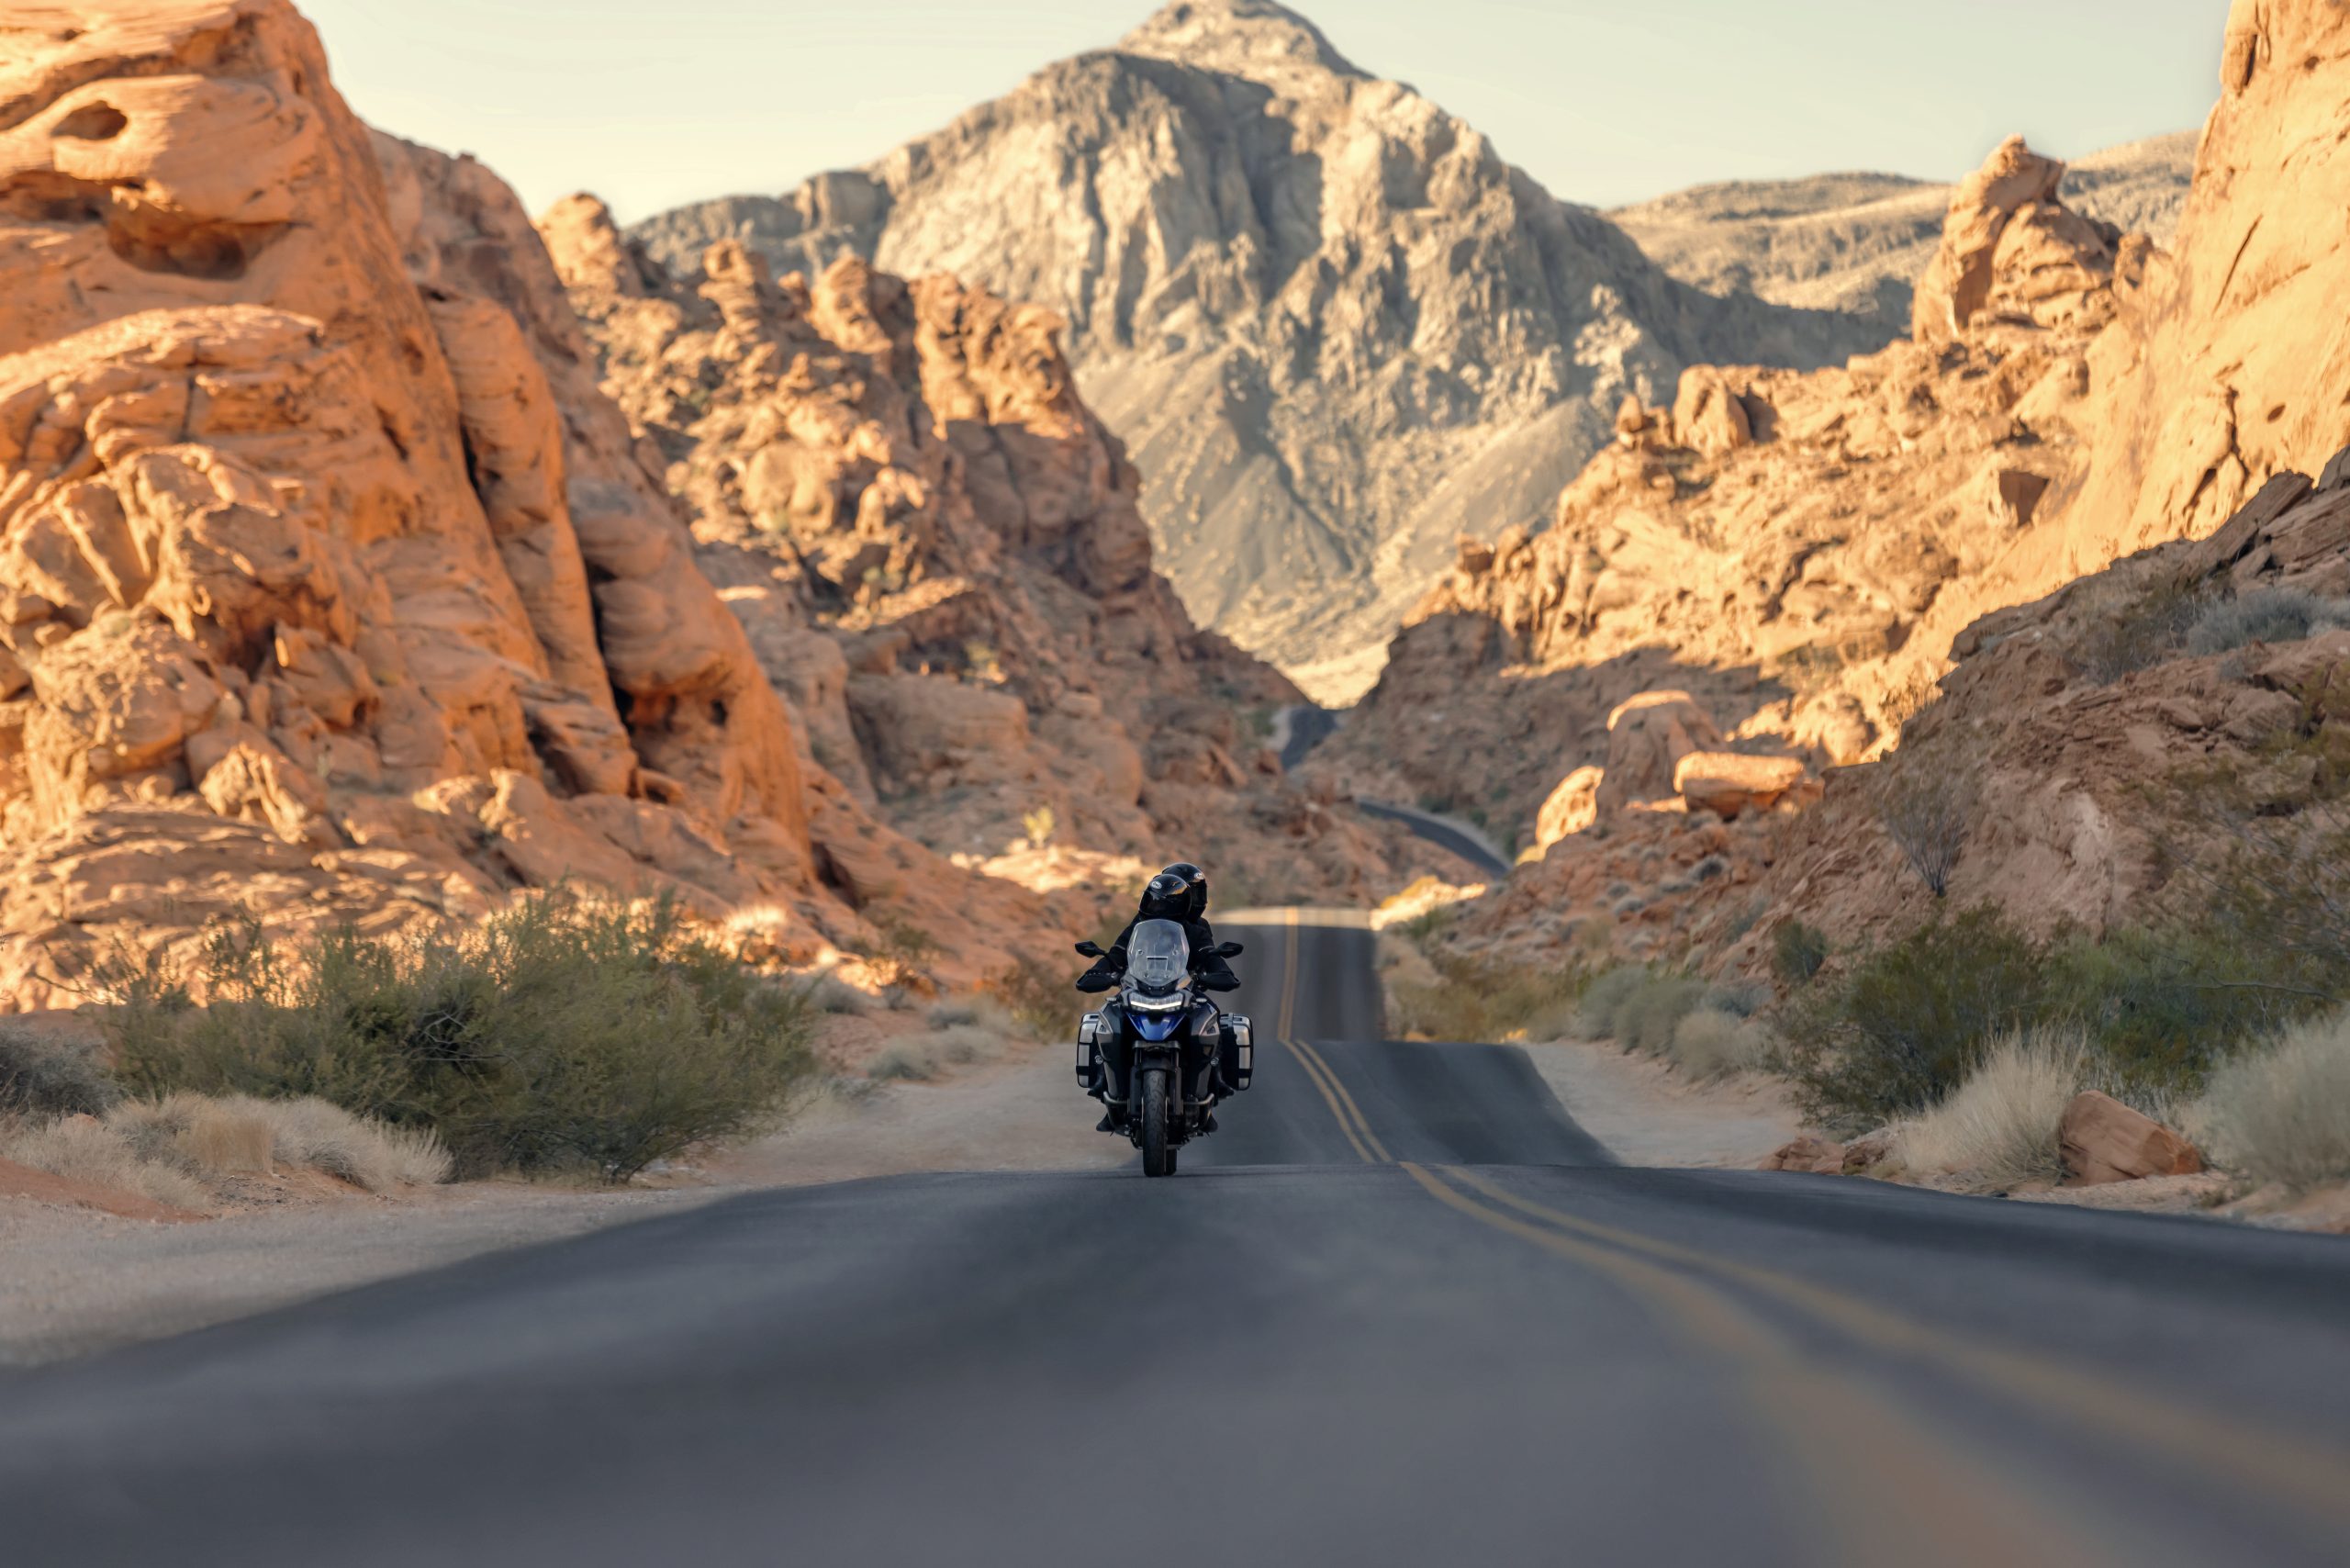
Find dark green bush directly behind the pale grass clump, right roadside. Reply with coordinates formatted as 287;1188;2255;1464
1779;905;2049;1124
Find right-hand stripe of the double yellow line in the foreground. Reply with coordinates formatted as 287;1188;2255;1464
1445;1166;2350;1523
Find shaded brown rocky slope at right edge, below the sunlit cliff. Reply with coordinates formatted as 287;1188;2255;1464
1749;456;2350;958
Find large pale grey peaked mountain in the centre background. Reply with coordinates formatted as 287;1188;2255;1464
632;0;1885;700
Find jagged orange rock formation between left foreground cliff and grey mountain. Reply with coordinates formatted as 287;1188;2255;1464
543;197;1436;925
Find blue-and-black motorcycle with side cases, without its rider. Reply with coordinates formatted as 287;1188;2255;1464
1076;919;1255;1175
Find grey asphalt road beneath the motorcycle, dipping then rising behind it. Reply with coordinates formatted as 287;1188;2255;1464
0;924;2350;1568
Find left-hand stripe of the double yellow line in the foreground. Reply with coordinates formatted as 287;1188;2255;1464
1401;1159;2112;1568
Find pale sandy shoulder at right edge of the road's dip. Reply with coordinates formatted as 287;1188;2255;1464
1525;1039;1800;1170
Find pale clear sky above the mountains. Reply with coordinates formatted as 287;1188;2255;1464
297;0;2228;221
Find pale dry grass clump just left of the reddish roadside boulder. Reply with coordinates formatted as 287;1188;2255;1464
1898;1027;2089;1190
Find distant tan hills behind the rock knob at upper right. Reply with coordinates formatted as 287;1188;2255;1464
1607;131;2195;339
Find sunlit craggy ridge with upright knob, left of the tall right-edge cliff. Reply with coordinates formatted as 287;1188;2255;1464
1314;141;2150;832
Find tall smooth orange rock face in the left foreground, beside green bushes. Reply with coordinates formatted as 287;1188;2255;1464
0;0;1044;1003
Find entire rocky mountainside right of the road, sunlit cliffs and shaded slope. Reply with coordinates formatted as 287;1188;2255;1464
1344;0;2350;969
